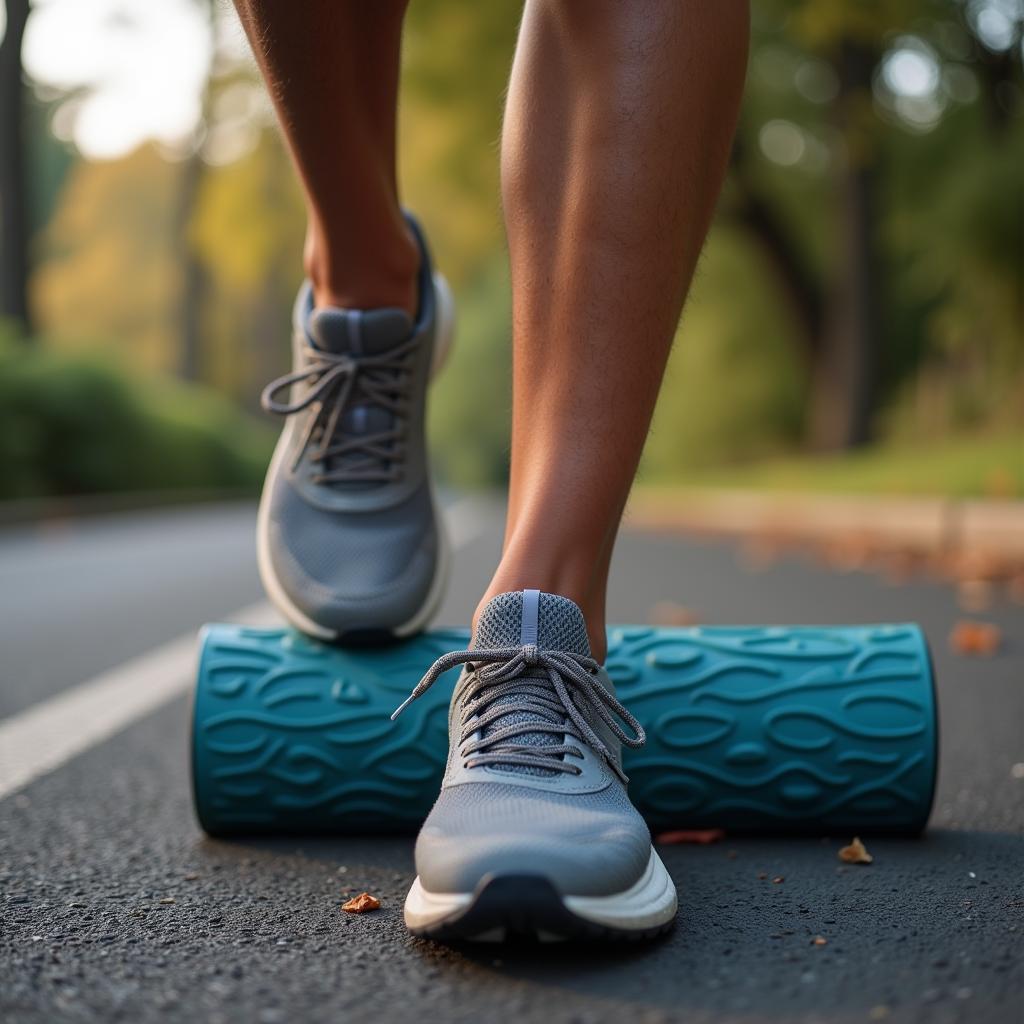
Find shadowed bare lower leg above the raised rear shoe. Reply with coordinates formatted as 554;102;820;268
236;0;419;313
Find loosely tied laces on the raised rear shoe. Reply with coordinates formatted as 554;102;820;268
260;338;417;483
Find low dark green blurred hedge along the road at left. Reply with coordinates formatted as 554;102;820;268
0;323;270;498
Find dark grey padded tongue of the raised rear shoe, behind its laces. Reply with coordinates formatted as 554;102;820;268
306;307;413;490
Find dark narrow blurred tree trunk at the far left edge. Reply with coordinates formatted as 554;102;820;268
0;0;32;335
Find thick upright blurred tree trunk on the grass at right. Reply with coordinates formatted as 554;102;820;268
810;41;879;451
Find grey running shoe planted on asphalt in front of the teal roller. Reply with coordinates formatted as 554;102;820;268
395;590;676;940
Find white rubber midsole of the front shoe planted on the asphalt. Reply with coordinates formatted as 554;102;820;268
404;847;679;941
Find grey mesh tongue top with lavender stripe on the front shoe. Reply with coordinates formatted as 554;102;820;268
473;590;590;657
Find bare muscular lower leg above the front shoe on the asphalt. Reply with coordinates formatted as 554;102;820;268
481;0;749;657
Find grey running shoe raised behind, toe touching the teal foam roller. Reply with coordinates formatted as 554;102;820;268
257;218;454;641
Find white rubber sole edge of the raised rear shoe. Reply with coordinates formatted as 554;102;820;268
256;271;455;641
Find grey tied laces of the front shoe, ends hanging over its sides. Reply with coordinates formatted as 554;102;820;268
391;644;646;782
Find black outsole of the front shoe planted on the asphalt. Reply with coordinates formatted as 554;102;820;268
410;874;674;942
